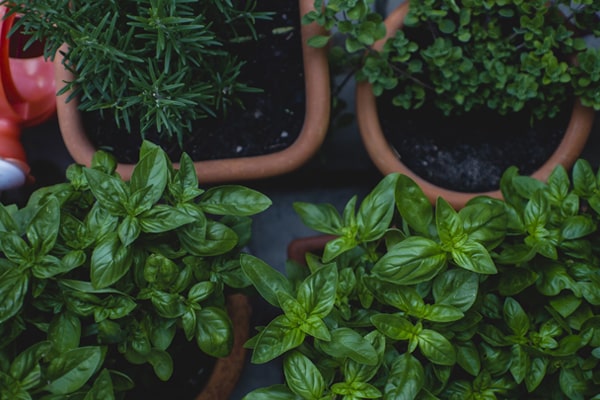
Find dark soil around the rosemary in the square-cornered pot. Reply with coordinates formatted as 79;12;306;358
84;0;305;163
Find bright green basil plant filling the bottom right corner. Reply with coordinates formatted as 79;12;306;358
242;160;600;400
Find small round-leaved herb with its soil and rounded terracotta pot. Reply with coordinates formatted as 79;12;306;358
305;0;600;207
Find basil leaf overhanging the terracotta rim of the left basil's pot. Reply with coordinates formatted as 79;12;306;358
196;307;233;357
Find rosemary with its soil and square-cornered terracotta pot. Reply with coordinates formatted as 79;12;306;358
2;0;330;183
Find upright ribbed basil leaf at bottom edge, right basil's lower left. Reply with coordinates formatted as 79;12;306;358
283;351;325;399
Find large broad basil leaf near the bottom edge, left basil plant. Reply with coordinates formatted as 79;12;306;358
45;346;103;395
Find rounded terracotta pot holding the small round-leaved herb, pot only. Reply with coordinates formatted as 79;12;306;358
356;2;594;209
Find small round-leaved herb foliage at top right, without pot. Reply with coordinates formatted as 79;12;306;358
304;0;600;119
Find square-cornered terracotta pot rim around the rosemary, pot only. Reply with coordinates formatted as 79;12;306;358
55;0;330;183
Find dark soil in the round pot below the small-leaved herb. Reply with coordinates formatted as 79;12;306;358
377;96;571;192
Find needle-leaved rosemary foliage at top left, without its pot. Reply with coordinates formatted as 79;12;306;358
0;0;270;143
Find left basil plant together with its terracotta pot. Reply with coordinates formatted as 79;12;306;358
0;142;270;400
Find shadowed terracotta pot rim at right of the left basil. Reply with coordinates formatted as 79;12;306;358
195;294;251;400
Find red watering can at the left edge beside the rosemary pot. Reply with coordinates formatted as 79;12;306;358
0;7;56;191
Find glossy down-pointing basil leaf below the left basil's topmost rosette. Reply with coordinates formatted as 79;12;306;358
90;233;132;289
